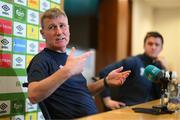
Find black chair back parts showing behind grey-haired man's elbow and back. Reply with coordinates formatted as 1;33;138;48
23;83;51;120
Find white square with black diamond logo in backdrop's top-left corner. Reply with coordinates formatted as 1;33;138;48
0;1;13;18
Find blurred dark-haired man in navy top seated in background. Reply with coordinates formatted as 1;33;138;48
99;31;167;109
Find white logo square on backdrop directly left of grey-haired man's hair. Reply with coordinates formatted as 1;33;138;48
27;9;39;25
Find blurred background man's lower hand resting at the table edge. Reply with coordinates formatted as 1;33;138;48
103;97;126;110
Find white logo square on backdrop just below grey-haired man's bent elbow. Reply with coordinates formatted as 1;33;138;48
26;99;38;112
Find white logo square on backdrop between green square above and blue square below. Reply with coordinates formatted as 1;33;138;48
14;22;26;37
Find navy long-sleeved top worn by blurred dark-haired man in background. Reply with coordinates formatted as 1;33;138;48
99;54;163;105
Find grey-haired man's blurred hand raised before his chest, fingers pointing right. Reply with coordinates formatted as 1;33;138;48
64;47;91;76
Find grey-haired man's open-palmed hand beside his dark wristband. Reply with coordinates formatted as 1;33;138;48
106;67;131;87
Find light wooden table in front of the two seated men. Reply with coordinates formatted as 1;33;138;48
78;100;180;120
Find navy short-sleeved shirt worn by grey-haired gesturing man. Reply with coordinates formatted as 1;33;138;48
27;48;97;119
